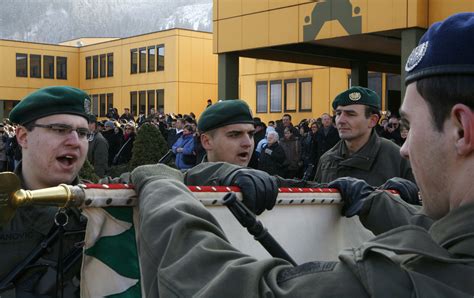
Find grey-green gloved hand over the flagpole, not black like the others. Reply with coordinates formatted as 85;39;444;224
130;164;183;193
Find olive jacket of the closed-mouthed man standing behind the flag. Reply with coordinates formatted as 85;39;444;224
314;131;415;186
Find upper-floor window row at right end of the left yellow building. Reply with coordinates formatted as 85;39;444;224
130;44;165;74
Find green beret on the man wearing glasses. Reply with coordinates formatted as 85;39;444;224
10;86;91;124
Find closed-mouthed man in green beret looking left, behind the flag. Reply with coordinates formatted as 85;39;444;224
314;86;415;186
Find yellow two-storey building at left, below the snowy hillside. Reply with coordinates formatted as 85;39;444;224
0;29;217;117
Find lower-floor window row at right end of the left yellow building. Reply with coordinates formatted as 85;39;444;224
130;89;165;116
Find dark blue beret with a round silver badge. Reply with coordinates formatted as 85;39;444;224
405;13;474;85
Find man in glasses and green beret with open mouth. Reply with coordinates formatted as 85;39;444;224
0;86;90;297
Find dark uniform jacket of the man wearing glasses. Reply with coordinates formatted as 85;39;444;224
0;162;86;298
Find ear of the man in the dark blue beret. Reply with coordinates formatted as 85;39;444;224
451;104;474;155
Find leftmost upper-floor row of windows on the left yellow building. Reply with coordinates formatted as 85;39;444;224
16;53;67;80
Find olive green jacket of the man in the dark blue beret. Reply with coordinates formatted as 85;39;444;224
135;163;474;298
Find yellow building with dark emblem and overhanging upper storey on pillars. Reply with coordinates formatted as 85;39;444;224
213;0;474;123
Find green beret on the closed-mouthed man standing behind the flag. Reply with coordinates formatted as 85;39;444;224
332;86;380;110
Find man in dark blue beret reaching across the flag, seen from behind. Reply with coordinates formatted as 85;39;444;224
132;13;474;297
